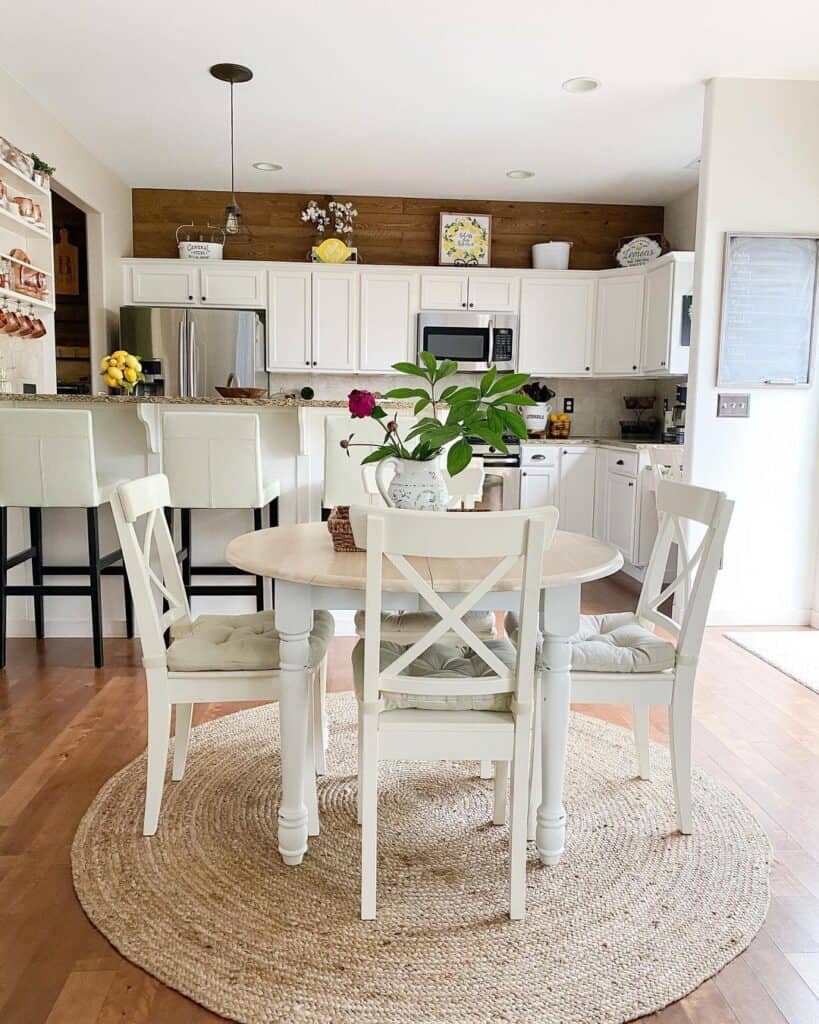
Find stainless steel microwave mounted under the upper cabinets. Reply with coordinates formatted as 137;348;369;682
418;310;518;373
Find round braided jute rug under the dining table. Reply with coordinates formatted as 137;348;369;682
72;694;770;1024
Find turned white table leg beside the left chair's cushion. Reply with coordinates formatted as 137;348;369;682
275;582;313;865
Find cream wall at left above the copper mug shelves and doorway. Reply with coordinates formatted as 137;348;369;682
0;70;132;385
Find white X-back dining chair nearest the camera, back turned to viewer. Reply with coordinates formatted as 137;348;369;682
353;508;558;920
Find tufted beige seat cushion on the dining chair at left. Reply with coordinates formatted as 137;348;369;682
167;611;335;672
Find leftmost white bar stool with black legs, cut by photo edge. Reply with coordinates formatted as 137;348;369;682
0;409;134;669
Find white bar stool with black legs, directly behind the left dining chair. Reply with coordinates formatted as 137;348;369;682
162;413;279;611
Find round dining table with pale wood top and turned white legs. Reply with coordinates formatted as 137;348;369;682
226;522;622;864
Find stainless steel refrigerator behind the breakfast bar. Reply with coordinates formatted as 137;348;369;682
120;306;268;397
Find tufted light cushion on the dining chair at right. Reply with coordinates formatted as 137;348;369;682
505;611;677;673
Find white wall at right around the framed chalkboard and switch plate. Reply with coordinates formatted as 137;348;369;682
686;79;819;624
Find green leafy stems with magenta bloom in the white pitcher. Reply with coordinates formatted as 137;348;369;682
341;352;534;476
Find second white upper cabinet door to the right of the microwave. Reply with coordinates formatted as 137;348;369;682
594;271;645;375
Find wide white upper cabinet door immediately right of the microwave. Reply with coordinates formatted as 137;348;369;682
518;275;595;377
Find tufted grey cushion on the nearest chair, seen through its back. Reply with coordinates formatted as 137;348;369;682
352;638;517;711
